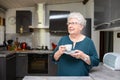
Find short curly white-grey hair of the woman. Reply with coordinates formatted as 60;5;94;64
67;12;86;27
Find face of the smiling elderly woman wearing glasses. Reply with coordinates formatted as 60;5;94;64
67;18;83;35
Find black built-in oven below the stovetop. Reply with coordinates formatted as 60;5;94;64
28;53;48;74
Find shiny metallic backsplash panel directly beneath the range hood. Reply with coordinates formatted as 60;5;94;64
33;28;51;49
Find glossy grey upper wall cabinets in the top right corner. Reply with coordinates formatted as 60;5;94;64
94;0;120;31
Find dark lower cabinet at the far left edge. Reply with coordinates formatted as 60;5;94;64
0;53;16;80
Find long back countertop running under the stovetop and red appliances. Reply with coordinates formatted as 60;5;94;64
0;50;53;57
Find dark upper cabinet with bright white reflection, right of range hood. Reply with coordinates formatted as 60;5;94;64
49;10;70;33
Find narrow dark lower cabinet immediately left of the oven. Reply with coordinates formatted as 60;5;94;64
16;53;28;78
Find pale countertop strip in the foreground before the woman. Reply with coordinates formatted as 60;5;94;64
23;76;93;80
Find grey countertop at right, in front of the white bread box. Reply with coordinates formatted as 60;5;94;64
90;63;120;80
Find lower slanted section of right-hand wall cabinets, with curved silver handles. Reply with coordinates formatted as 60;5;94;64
94;18;120;31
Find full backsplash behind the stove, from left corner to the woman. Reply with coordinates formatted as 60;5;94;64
6;28;67;49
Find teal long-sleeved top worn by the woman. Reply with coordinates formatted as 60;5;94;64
53;36;99;76
